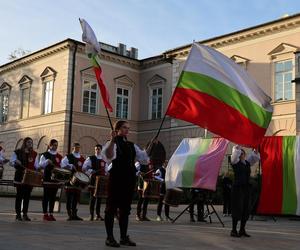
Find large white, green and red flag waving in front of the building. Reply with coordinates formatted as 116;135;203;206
166;43;273;147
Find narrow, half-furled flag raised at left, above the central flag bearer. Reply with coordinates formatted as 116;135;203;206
79;18;112;112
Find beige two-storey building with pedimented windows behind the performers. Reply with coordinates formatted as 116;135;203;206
0;14;300;182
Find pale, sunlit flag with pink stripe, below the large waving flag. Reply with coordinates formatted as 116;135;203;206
166;138;229;191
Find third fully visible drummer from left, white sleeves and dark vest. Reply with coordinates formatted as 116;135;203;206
60;142;85;221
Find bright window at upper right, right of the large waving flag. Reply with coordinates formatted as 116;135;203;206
274;60;295;102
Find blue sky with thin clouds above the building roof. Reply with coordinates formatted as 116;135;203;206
0;0;300;65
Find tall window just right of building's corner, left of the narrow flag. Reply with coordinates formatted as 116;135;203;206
82;80;97;114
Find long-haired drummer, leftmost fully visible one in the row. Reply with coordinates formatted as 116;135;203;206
10;137;39;221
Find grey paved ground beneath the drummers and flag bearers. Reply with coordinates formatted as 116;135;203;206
0;198;300;250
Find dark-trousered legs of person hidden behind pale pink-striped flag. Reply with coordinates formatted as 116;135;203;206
189;188;206;222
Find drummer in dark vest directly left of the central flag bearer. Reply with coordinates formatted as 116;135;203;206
82;144;107;221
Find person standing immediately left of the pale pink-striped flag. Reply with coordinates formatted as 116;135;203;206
154;162;172;221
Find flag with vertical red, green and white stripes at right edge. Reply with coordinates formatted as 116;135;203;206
257;136;300;215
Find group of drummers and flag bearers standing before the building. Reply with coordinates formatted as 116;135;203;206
0;120;259;247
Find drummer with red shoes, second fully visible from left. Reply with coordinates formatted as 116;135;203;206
39;139;62;221
